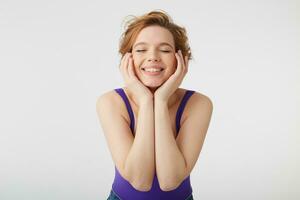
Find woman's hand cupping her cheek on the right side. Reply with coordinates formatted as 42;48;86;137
154;50;188;102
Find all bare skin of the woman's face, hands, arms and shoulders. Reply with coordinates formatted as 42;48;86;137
97;26;213;191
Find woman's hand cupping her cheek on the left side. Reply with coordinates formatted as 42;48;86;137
120;52;153;105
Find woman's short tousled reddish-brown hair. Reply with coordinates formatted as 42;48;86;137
119;10;192;60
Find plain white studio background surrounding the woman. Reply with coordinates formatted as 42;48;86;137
0;0;300;200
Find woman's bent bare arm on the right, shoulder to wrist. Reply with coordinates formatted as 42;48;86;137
155;93;212;191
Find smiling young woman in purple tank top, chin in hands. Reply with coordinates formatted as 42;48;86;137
96;11;213;200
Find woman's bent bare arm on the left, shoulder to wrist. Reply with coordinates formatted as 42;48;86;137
97;93;154;191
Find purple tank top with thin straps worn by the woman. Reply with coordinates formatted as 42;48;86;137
112;88;194;200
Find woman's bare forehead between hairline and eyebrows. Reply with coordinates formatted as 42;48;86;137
133;26;174;47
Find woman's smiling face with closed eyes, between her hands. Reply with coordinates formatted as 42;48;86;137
132;26;177;88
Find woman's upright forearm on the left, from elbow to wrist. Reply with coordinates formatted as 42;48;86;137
124;100;155;191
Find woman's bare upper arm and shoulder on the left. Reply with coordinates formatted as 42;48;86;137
96;90;134;180
